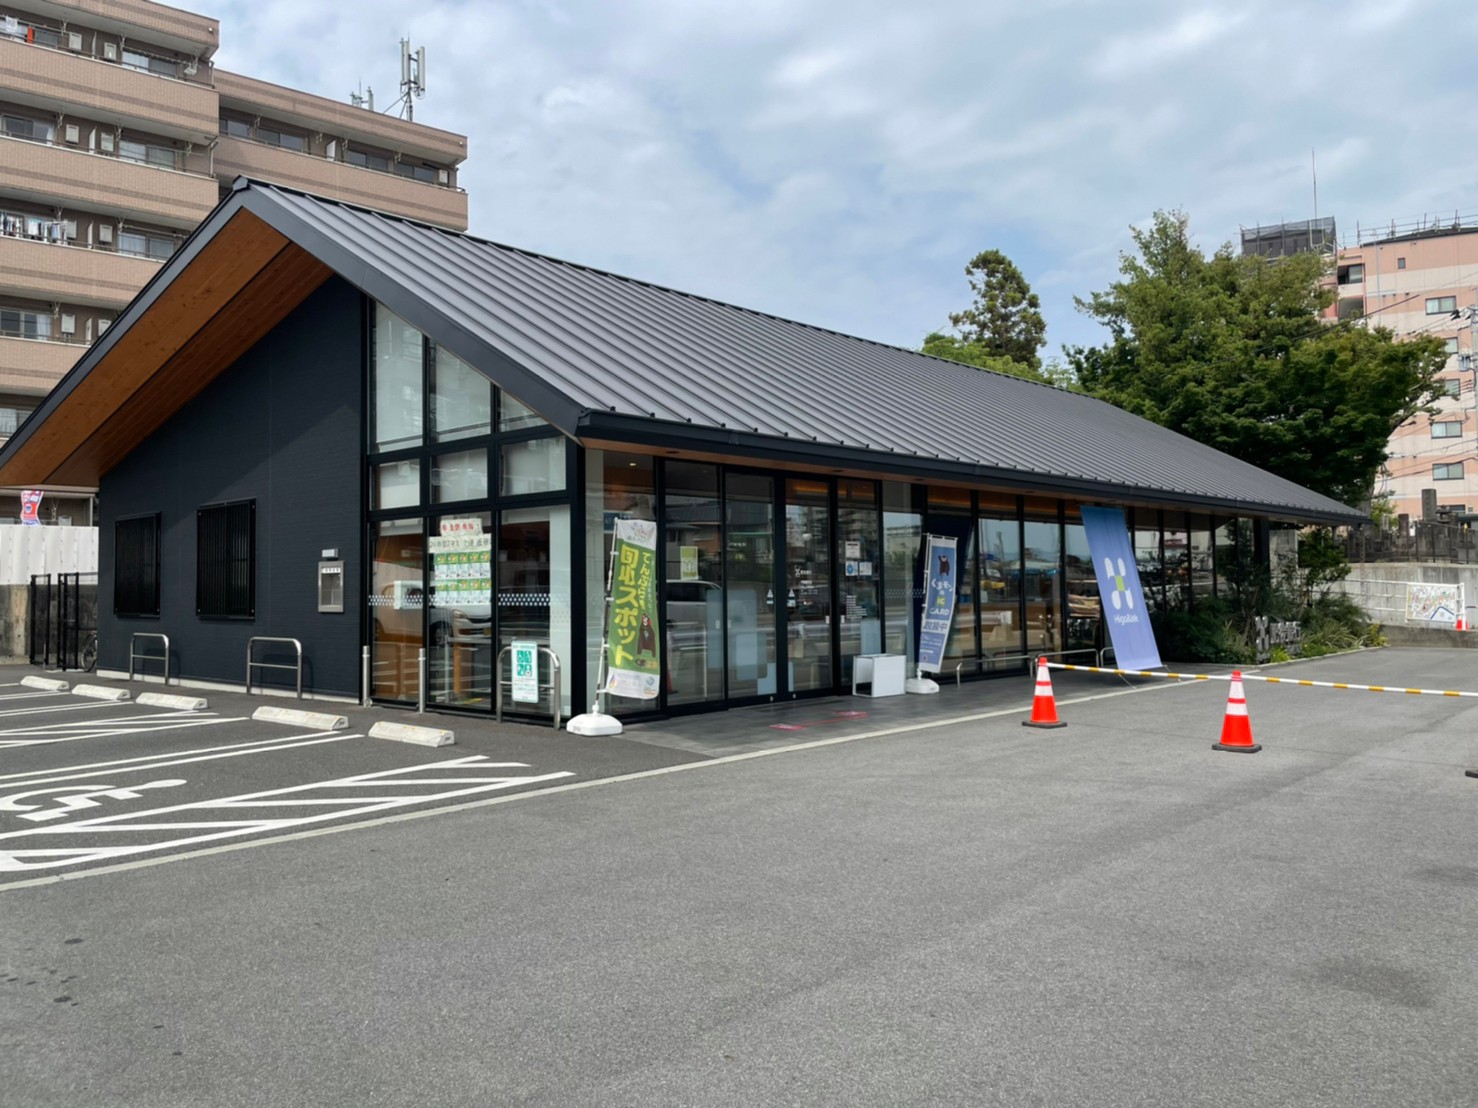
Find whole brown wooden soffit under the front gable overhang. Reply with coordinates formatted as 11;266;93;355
0;211;331;488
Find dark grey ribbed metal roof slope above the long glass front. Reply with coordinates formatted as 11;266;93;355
0;182;1364;523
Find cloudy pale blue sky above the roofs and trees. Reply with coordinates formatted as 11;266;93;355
215;0;1478;355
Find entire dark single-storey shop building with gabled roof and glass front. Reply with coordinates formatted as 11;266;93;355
0;182;1361;715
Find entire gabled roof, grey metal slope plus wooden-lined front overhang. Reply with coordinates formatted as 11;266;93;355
0;180;1364;523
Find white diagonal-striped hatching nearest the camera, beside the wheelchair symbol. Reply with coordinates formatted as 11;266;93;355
0;755;575;872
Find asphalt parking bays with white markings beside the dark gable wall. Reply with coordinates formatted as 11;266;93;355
0;666;695;886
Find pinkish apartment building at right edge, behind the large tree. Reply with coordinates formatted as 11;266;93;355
1335;223;1478;520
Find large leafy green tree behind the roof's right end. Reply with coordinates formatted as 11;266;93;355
1066;211;1445;504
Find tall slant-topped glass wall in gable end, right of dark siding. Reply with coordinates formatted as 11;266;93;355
367;304;573;714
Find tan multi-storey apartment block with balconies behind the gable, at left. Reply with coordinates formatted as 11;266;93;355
0;0;467;524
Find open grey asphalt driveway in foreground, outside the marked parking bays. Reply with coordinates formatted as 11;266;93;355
0;650;1478;1108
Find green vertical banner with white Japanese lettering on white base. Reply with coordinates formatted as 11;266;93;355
606;519;662;700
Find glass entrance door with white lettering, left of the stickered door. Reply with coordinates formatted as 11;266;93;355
785;479;835;694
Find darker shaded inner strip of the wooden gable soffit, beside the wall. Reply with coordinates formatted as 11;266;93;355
47;247;333;486
